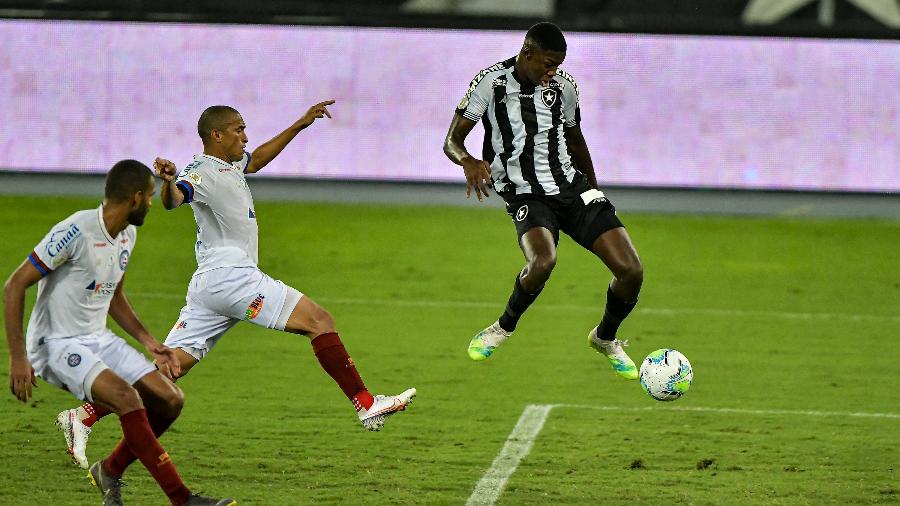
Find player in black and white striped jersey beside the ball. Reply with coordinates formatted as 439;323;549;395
444;22;644;379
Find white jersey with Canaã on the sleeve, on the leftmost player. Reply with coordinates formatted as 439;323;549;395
25;205;137;351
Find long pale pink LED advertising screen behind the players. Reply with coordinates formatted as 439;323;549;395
0;21;900;192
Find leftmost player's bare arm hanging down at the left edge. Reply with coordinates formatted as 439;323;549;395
3;260;41;402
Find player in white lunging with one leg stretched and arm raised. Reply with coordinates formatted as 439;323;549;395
60;100;416;461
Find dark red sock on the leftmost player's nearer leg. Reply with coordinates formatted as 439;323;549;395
110;409;191;504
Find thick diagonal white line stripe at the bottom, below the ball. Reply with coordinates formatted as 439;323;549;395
466;404;553;506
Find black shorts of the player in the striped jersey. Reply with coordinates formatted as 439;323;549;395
506;183;624;251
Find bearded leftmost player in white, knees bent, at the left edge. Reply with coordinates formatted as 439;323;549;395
3;160;235;505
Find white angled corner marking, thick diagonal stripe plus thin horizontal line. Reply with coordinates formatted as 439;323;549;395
466;404;900;506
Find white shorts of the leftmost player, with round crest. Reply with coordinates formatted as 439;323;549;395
28;329;156;402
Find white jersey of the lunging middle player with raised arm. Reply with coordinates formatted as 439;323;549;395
176;152;259;273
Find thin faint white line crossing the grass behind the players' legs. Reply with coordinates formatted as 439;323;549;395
131;292;900;322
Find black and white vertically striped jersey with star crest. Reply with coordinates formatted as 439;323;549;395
456;57;581;198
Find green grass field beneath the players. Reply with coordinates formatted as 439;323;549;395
0;193;900;505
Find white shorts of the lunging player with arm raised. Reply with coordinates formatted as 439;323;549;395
165;267;303;360
